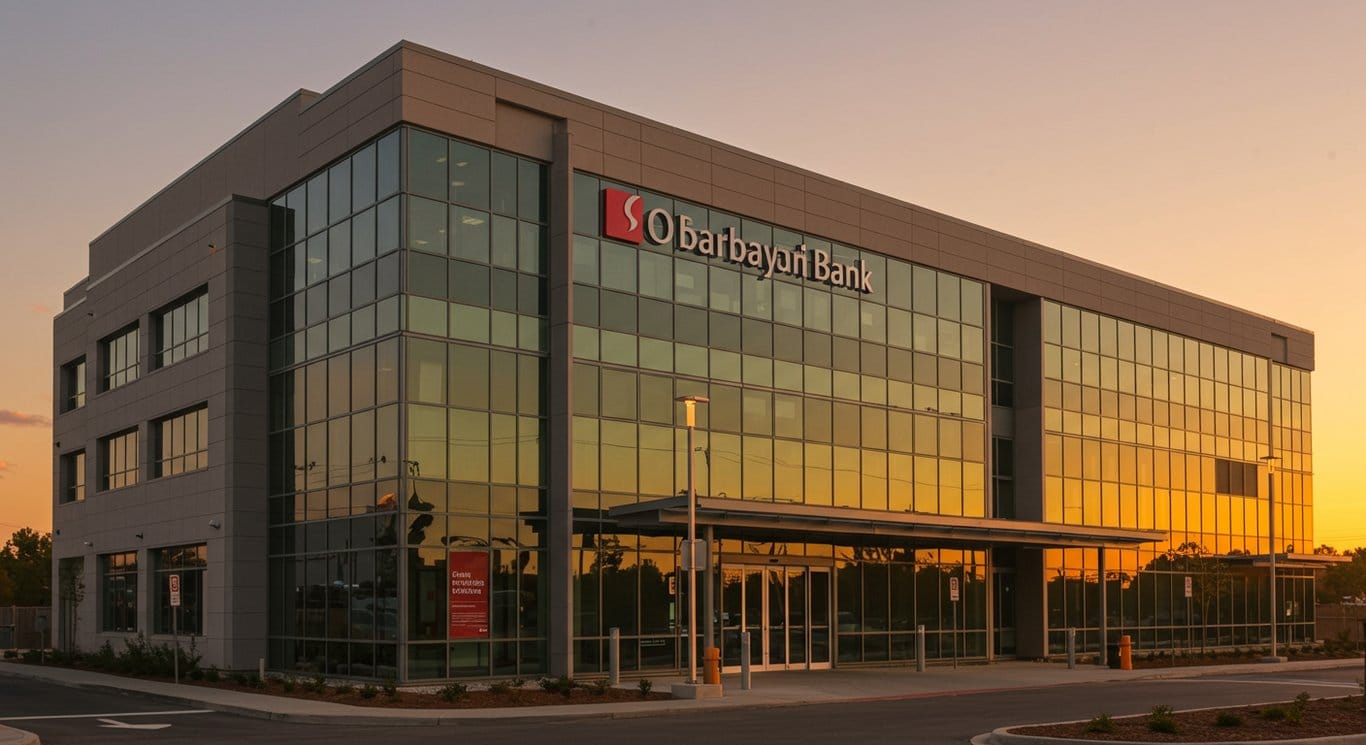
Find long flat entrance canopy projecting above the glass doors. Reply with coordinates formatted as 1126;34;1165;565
608;496;1167;548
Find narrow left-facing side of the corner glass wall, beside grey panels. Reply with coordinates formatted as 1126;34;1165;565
269;131;403;678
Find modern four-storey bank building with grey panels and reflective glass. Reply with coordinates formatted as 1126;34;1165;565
53;42;1314;681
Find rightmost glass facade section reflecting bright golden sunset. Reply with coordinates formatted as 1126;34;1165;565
1042;301;1314;653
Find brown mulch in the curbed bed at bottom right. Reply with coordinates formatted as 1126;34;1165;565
1011;696;1366;742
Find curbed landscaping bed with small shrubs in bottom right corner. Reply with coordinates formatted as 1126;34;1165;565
1009;693;1366;742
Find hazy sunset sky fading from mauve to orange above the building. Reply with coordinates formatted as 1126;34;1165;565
0;0;1366;548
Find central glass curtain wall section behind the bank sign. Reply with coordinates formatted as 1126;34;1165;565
571;174;989;671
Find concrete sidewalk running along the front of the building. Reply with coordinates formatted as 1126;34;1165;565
0;659;1361;726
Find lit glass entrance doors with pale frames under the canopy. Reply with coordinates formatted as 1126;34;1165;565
720;565;831;670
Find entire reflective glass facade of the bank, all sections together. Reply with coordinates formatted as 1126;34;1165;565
256;121;1313;681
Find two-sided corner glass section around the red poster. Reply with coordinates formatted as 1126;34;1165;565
270;130;548;679
